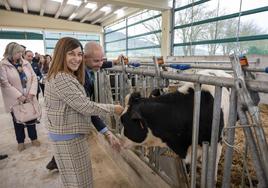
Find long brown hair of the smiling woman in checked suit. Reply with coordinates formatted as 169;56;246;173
47;37;85;85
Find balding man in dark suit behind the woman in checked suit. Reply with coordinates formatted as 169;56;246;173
46;42;121;170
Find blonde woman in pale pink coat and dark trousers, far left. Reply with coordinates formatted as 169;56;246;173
0;42;40;151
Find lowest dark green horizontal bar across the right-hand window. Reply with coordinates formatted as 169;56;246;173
174;34;268;46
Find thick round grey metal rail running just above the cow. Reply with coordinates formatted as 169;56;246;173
107;66;268;93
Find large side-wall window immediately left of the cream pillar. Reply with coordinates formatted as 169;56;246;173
104;10;162;58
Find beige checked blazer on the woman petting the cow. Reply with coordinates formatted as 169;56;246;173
45;72;114;134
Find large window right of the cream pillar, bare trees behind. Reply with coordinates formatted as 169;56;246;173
172;0;268;56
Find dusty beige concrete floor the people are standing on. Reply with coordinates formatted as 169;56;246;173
0;92;133;188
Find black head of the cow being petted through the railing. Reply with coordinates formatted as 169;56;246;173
120;92;148;146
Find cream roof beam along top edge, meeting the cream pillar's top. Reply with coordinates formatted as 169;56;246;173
90;0;171;11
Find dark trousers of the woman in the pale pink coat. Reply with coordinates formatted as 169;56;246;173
11;113;37;144
